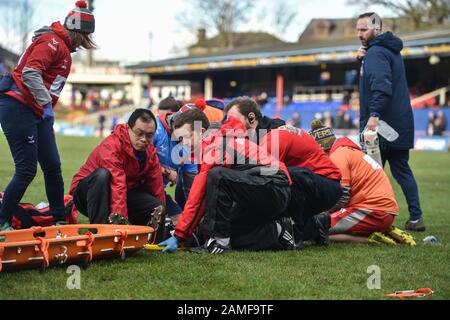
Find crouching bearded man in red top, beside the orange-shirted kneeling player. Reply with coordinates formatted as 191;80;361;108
225;97;342;249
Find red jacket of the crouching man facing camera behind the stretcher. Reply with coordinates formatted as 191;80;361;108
70;124;166;217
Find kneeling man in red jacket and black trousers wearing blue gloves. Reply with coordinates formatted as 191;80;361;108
160;110;294;254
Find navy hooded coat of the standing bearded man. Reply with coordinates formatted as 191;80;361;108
359;32;414;149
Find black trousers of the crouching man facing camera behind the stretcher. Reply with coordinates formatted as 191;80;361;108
73;168;163;225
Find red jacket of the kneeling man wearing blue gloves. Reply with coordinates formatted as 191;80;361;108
175;117;292;239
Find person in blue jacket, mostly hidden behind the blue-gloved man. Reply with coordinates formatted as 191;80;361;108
153;98;209;225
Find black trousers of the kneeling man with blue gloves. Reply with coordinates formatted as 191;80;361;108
201;167;290;250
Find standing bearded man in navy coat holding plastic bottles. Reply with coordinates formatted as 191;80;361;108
357;13;425;231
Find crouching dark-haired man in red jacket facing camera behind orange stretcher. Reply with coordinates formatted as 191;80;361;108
70;109;165;231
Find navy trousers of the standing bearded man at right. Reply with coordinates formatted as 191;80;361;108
381;148;422;221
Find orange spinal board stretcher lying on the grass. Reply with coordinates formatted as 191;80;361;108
0;224;154;271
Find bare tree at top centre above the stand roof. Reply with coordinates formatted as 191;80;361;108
178;0;254;48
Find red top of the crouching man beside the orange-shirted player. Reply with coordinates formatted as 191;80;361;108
260;126;341;180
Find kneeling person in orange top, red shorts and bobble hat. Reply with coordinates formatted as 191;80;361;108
311;120;413;245
